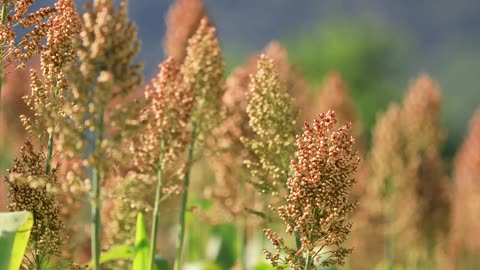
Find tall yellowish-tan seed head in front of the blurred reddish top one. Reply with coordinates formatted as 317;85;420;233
180;18;225;136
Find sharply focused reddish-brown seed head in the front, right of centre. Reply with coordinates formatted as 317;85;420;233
264;111;360;269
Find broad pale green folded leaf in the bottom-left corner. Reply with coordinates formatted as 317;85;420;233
0;211;33;270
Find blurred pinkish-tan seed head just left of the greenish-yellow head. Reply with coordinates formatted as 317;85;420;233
204;57;261;221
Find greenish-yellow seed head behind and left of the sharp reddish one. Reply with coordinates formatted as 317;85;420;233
242;55;298;196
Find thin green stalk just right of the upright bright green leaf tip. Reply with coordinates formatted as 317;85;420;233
149;140;165;270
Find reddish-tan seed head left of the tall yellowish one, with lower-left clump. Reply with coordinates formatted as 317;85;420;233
107;58;195;249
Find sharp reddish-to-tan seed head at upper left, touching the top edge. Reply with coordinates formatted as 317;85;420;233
21;0;79;143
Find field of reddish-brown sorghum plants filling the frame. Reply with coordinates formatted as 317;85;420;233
0;0;480;270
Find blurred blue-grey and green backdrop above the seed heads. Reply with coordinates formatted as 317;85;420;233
124;0;480;158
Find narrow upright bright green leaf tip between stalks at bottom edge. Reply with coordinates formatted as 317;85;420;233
133;213;156;270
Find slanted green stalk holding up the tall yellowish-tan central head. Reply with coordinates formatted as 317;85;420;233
175;124;196;270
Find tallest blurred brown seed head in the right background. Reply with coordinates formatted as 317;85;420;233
399;74;450;249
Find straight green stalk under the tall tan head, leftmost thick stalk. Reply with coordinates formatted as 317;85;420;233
90;108;104;270
